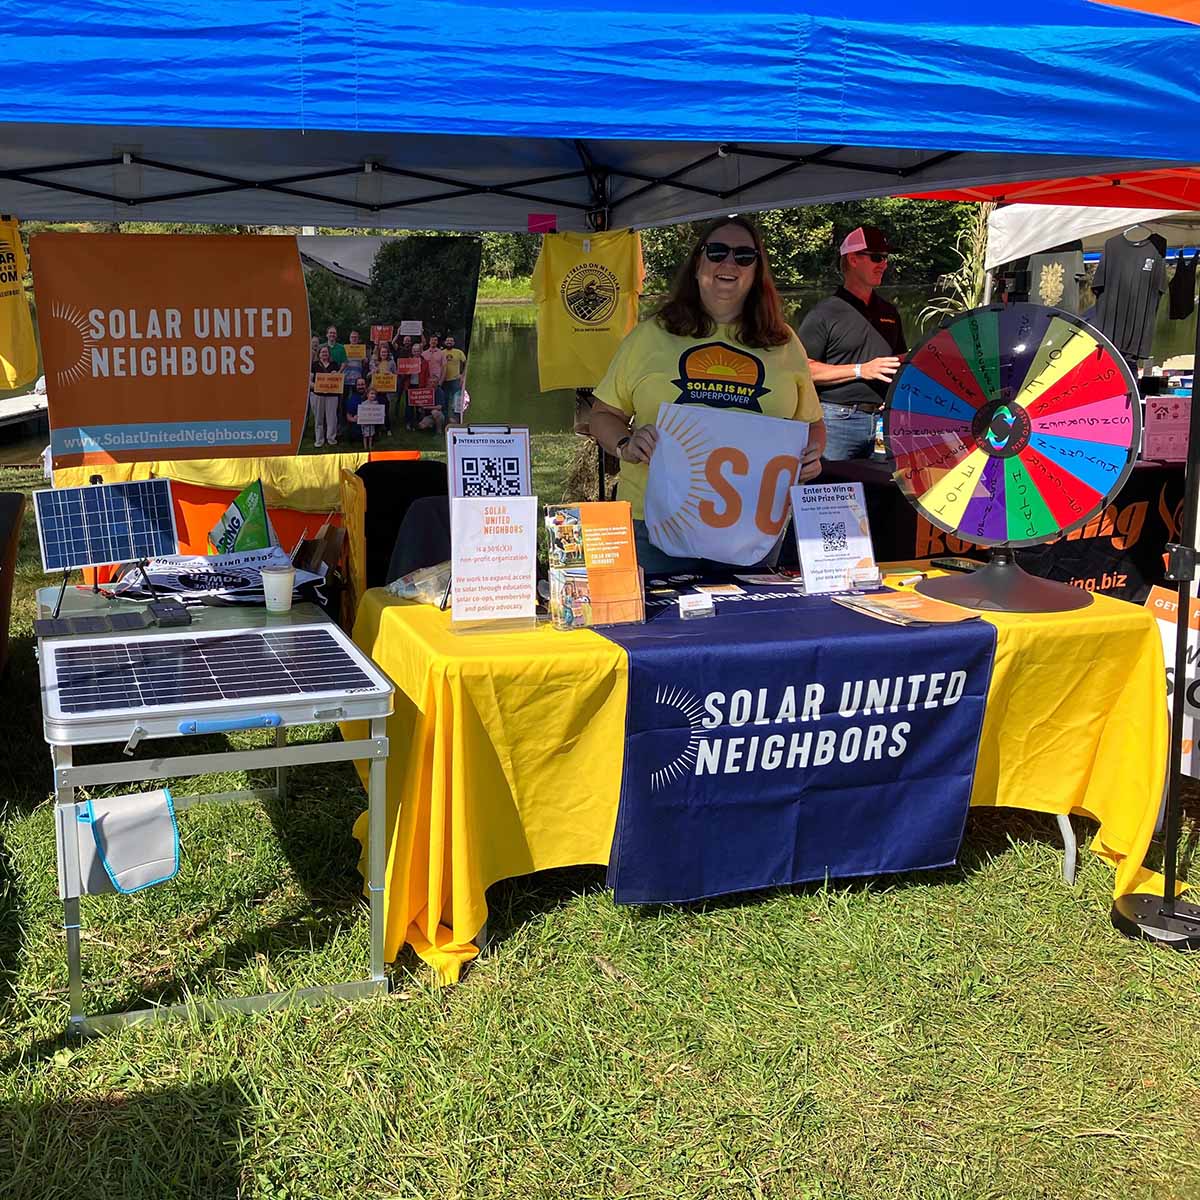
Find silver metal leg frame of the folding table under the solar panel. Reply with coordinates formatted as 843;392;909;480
38;589;389;1036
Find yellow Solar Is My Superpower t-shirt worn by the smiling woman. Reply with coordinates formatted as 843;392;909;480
595;317;821;521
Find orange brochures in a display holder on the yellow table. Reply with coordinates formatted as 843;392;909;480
546;500;646;629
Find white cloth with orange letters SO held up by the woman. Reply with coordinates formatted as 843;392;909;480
646;404;809;566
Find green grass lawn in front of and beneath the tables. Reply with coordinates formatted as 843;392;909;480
0;451;1200;1200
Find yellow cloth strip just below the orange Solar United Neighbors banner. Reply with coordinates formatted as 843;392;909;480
54;452;367;512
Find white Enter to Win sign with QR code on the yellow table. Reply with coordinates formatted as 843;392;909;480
792;484;880;595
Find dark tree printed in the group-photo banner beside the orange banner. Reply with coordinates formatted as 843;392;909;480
366;236;481;346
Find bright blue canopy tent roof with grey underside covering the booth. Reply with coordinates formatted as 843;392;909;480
0;0;1200;230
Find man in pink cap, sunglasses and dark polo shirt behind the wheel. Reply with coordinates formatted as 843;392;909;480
799;226;908;462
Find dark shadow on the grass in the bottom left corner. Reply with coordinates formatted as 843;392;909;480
0;1081;248;1200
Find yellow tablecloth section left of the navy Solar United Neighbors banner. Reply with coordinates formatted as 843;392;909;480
347;588;626;983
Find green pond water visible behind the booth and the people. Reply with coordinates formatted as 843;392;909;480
0;287;1195;463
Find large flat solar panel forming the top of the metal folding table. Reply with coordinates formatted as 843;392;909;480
54;626;380;714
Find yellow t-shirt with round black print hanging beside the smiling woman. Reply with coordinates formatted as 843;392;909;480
533;229;646;391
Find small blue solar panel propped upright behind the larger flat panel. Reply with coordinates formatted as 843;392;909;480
34;479;179;571
